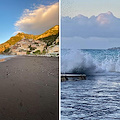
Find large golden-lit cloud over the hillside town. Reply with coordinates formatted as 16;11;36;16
15;2;59;34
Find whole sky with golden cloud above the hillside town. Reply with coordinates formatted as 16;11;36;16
0;0;59;44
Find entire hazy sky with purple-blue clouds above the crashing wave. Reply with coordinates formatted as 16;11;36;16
61;0;120;49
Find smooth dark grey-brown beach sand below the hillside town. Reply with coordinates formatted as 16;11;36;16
0;56;59;120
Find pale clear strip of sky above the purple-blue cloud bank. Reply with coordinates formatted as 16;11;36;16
61;0;120;18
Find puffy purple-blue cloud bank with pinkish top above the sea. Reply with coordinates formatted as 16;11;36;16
62;12;120;38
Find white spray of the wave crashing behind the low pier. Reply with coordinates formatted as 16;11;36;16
61;51;120;75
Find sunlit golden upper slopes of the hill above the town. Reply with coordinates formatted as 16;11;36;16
0;25;59;53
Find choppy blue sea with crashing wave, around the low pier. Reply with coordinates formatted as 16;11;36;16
61;49;120;120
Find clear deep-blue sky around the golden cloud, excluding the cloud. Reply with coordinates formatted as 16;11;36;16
0;0;58;43
